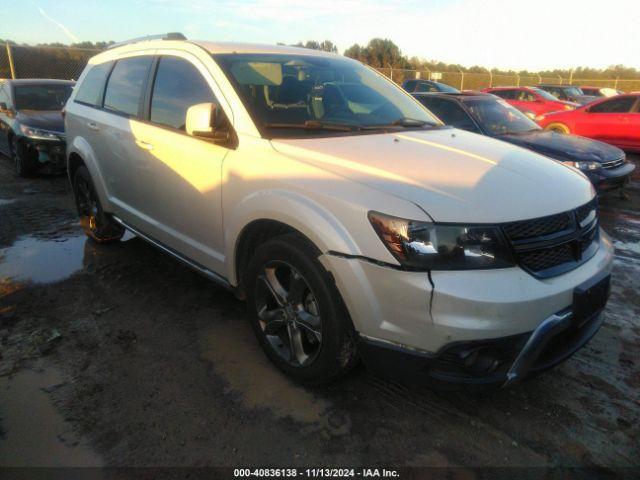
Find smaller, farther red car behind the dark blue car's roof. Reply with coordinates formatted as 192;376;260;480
482;87;579;120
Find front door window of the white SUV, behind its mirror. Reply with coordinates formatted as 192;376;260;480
151;56;218;130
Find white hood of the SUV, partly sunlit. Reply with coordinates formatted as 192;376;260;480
272;128;594;223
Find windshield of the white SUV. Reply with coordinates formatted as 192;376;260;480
213;54;440;136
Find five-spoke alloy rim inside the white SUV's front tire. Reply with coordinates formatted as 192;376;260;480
255;260;322;367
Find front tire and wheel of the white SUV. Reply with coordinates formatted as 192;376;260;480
244;234;357;384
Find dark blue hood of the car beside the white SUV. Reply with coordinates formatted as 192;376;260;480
496;130;624;162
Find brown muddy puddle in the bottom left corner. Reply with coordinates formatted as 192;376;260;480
0;368;103;467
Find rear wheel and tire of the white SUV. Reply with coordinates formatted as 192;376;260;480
73;166;124;243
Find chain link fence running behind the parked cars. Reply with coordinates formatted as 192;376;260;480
0;44;640;92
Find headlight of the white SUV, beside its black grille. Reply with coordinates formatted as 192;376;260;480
369;212;514;270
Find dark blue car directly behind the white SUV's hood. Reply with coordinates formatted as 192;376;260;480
413;93;635;191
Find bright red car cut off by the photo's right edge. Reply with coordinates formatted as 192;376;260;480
538;93;640;152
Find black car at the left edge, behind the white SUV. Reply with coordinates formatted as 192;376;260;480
0;79;74;177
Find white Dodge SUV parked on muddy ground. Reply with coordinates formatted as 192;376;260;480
66;34;612;387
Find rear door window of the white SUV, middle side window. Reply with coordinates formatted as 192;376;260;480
104;56;153;117
